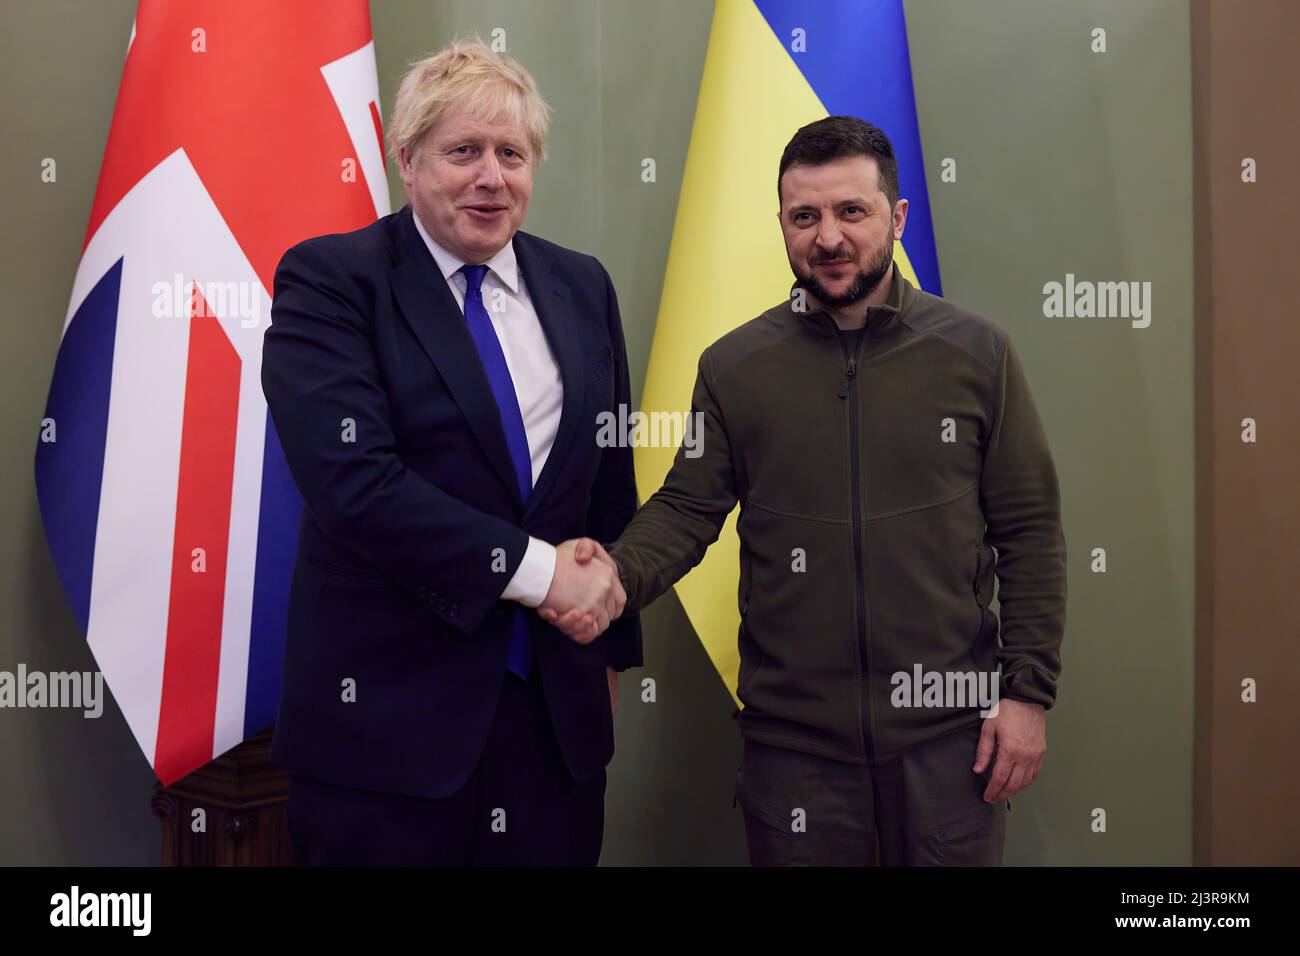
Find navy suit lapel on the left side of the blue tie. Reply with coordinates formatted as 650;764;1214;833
390;206;522;506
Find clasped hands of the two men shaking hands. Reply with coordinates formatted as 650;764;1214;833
537;537;628;644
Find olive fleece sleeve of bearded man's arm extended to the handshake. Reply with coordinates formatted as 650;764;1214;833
610;350;737;610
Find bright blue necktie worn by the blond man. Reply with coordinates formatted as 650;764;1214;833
460;265;533;680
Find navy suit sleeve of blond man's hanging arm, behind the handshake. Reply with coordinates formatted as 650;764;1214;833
586;267;645;671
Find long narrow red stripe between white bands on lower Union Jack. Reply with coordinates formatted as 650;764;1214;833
153;287;241;786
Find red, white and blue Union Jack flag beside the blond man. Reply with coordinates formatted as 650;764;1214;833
36;0;389;784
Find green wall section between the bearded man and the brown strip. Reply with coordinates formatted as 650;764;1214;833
906;0;1195;865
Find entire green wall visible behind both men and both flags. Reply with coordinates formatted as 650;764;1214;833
0;0;1193;865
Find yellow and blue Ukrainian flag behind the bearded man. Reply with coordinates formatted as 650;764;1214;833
636;0;943;704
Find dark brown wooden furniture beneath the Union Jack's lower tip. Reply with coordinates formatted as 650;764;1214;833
152;728;294;866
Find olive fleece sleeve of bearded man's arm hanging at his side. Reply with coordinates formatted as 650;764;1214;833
980;337;1066;708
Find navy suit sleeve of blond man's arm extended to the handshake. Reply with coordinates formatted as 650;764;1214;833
261;241;528;635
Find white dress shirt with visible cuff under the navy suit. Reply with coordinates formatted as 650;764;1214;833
412;215;564;607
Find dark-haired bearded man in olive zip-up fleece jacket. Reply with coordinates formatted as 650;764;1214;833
543;117;1066;864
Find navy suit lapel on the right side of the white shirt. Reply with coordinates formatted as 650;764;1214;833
515;233;594;516
